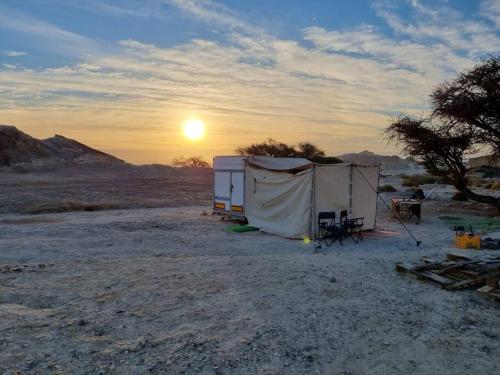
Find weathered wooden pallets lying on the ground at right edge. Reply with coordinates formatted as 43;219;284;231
396;253;500;296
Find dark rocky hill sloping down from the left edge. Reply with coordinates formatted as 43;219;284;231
0;125;125;167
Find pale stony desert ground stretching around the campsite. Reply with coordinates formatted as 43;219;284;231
0;171;500;375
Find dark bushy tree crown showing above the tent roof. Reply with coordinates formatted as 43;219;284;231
236;138;342;164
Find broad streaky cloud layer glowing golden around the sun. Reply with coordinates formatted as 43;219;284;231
0;0;500;162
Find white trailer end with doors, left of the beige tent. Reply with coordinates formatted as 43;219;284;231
213;156;245;217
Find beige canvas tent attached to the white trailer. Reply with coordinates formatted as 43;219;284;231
244;157;379;238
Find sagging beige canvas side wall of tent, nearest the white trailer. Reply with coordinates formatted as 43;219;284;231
245;164;313;238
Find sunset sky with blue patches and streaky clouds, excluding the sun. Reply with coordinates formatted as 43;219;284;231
0;0;500;164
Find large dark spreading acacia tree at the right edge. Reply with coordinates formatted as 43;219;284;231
386;56;500;212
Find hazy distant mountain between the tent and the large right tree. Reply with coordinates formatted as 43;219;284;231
338;151;424;174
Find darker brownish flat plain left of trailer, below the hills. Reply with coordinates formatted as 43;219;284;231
0;165;212;215
